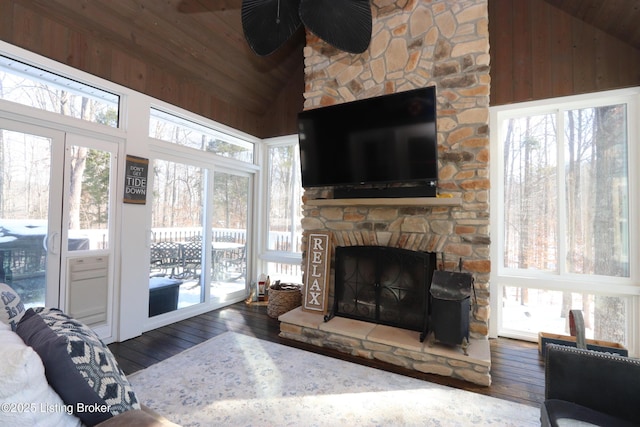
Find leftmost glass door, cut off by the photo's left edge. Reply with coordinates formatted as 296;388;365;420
0;119;64;307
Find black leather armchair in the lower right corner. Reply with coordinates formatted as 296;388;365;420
541;344;640;427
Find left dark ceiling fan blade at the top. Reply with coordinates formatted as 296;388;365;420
242;0;302;56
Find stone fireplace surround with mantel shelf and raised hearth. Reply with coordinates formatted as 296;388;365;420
279;197;491;386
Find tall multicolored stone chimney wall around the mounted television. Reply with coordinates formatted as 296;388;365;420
302;0;491;337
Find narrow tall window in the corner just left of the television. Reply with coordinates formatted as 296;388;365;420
263;137;302;282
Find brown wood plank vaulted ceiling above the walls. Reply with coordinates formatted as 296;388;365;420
6;0;640;115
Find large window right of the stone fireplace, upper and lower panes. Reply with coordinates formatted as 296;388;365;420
492;91;637;344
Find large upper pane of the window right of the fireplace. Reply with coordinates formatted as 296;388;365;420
502;104;629;277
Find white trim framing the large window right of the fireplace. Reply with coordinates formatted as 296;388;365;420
489;88;640;355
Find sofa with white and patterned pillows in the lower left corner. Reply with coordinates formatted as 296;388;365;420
0;283;177;427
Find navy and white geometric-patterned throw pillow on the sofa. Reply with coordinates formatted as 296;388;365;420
16;308;140;426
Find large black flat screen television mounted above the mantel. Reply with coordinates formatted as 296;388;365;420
298;86;438;201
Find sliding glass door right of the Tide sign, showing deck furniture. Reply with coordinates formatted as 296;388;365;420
149;159;251;317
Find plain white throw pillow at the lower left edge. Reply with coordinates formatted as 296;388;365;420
0;323;80;427
